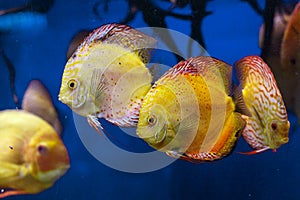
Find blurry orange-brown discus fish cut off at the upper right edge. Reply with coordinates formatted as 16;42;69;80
280;2;300;73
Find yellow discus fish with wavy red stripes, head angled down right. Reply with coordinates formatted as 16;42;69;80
235;56;290;154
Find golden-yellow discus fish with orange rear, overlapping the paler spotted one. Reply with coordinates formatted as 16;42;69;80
137;56;246;162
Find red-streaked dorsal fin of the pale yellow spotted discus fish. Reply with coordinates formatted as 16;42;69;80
80;24;156;63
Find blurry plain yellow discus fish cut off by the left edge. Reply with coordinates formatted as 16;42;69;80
0;110;69;198
